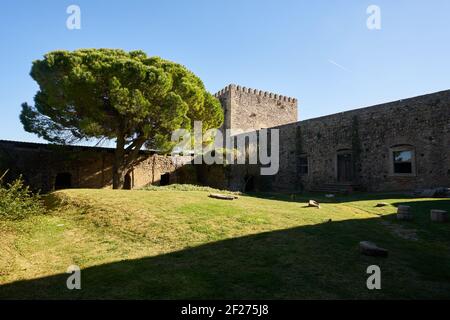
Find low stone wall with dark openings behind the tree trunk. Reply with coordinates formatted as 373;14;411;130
0;141;195;192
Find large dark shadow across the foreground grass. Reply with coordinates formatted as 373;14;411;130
0;206;450;299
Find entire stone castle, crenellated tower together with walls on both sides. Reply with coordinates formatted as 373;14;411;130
0;85;450;191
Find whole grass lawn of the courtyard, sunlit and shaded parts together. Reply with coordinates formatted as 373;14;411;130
0;189;450;299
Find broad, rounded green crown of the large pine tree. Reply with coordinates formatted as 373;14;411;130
20;49;223;147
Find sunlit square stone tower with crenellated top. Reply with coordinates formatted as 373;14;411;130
215;84;297;132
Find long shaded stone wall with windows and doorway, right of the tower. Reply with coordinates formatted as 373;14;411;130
272;90;450;191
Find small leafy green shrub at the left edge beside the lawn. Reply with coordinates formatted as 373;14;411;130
0;172;45;220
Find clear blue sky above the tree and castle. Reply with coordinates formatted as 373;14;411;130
0;0;450;141
